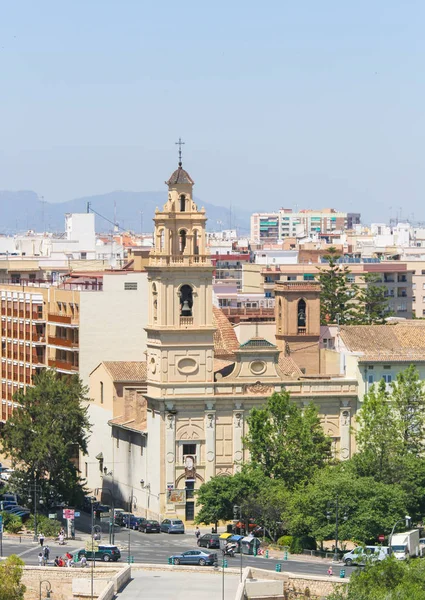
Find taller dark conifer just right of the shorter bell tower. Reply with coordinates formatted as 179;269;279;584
318;247;358;325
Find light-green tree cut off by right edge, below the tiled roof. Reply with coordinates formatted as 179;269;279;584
391;365;425;455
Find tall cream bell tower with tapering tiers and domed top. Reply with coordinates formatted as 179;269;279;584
146;157;215;400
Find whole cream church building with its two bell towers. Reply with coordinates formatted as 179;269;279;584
83;162;357;521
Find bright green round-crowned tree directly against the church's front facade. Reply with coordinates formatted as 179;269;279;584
244;391;331;488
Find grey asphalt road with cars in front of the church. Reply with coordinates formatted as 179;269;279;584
3;528;354;577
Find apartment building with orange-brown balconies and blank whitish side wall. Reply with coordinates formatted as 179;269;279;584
0;271;147;421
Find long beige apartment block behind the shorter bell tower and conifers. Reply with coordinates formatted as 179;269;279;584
242;259;412;319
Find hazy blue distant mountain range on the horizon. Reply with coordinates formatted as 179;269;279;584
0;191;251;235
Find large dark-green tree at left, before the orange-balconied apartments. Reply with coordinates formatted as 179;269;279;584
1;370;90;506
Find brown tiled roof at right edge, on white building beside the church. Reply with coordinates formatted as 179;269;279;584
340;321;425;362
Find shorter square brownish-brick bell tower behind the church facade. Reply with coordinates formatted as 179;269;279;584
275;281;320;375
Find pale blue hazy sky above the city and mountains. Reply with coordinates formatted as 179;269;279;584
0;0;425;221
